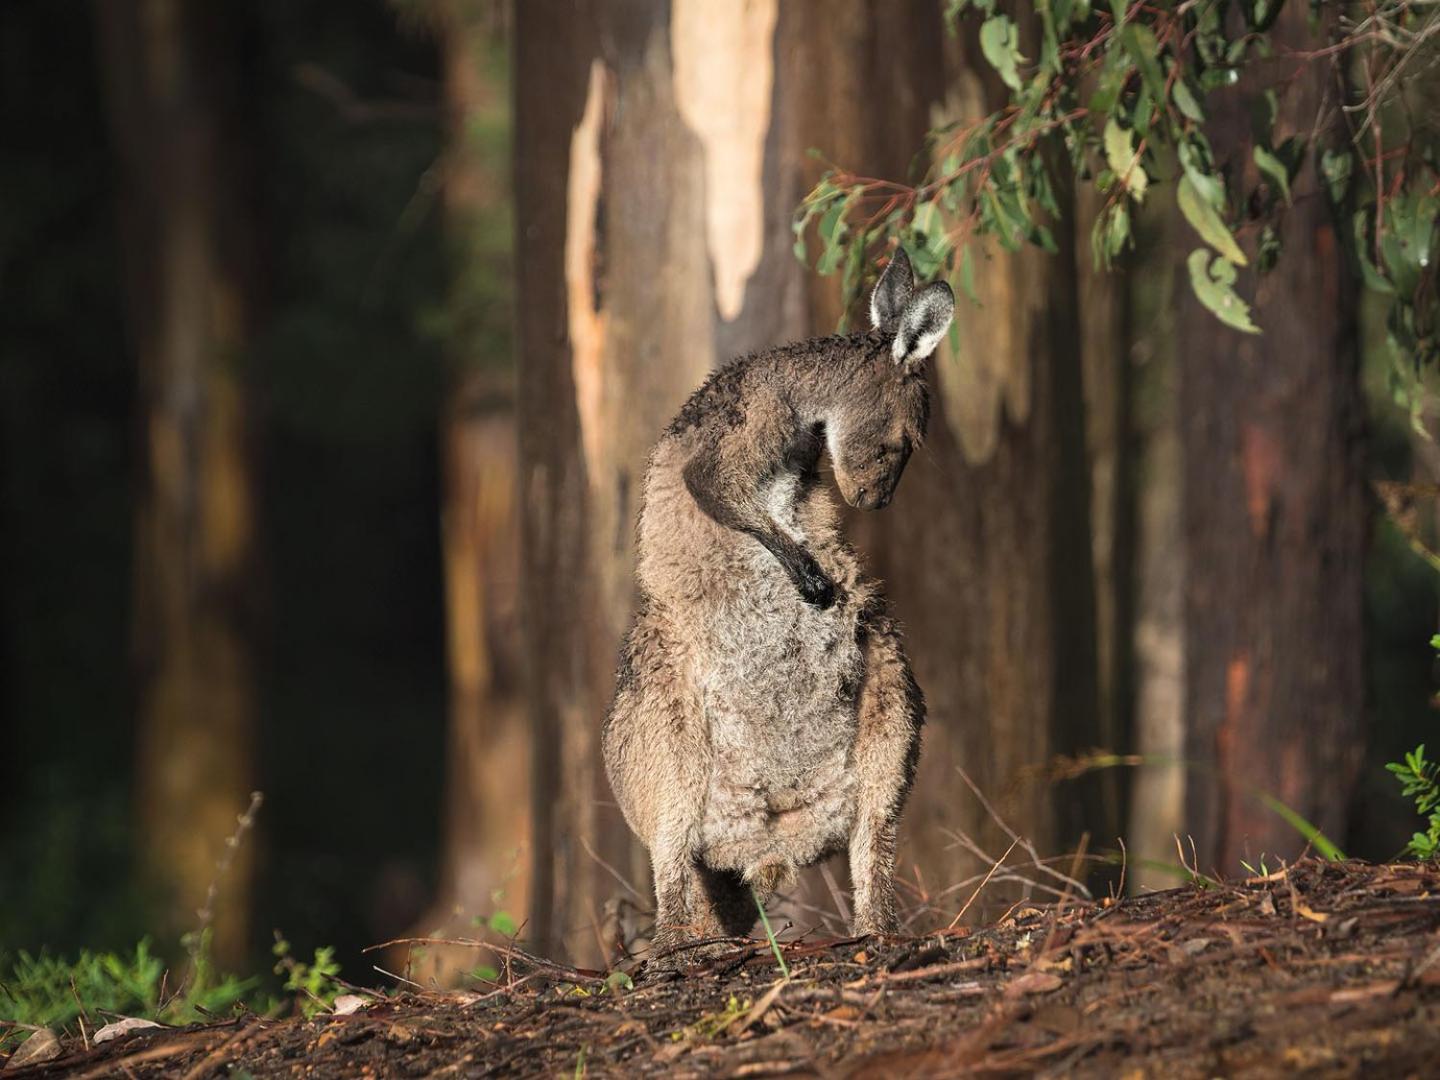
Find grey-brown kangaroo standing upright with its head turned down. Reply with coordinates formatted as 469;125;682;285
602;251;955;966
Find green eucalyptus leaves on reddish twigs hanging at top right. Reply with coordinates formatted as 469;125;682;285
793;0;1440;408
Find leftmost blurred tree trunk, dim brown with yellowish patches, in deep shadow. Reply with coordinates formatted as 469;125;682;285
96;0;256;962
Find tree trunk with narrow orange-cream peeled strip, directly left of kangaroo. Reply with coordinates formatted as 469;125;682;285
514;0;714;958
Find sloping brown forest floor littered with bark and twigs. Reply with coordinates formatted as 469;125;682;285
6;860;1440;1080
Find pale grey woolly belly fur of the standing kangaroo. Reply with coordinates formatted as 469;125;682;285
693;544;863;877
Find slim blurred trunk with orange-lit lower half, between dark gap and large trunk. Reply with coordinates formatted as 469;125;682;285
412;0;530;982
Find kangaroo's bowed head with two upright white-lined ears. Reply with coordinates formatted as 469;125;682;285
825;248;955;510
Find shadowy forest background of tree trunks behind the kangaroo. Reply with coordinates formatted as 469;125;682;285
0;0;1440;1048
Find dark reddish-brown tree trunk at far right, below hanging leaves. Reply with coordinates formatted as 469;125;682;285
1178;4;1367;873
